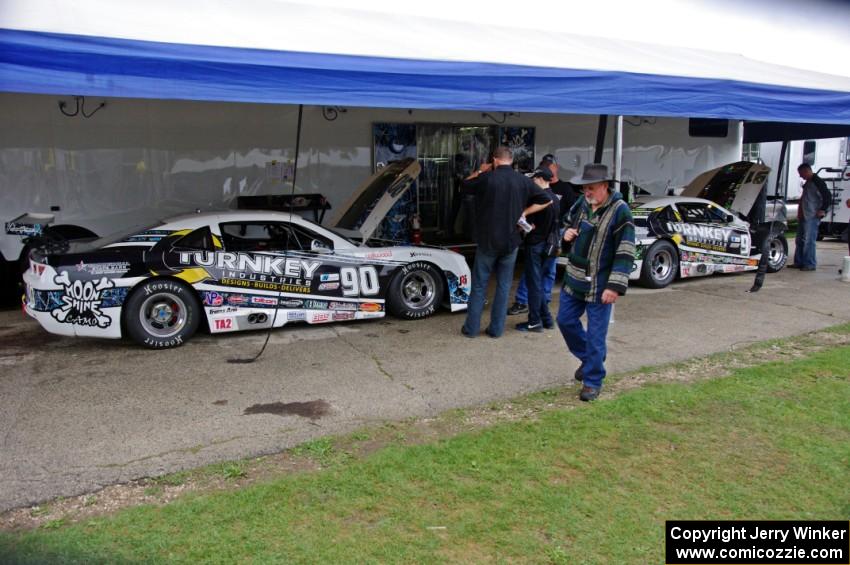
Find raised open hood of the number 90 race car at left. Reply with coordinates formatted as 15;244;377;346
330;157;420;244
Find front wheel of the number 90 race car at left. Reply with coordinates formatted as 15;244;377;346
387;261;444;320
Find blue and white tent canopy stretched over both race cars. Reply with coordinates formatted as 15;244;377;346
0;0;850;124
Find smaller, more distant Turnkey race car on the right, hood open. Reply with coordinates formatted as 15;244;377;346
630;161;788;288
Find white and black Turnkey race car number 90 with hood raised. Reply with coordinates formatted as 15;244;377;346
24;156;470;348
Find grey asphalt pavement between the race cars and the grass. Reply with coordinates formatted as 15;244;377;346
0;241;850;511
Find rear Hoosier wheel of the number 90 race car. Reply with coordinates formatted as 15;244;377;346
121;279;202;349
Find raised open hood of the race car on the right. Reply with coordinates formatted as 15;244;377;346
682;161;770;216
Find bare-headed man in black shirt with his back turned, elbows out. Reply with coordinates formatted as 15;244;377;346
461;146;552;338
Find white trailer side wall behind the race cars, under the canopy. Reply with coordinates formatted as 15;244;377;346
0;93;742;294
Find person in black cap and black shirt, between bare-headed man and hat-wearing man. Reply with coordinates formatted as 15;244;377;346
516;168;560;333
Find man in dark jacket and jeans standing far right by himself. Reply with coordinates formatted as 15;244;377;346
790;163;832;271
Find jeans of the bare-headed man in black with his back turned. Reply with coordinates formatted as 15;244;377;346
463;249;517;337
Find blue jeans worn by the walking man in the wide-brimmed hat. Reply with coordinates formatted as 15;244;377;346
558;290;611;388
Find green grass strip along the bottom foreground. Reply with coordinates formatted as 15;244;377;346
0;346;850;564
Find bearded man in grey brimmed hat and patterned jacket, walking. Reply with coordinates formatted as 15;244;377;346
557;163;635;401
